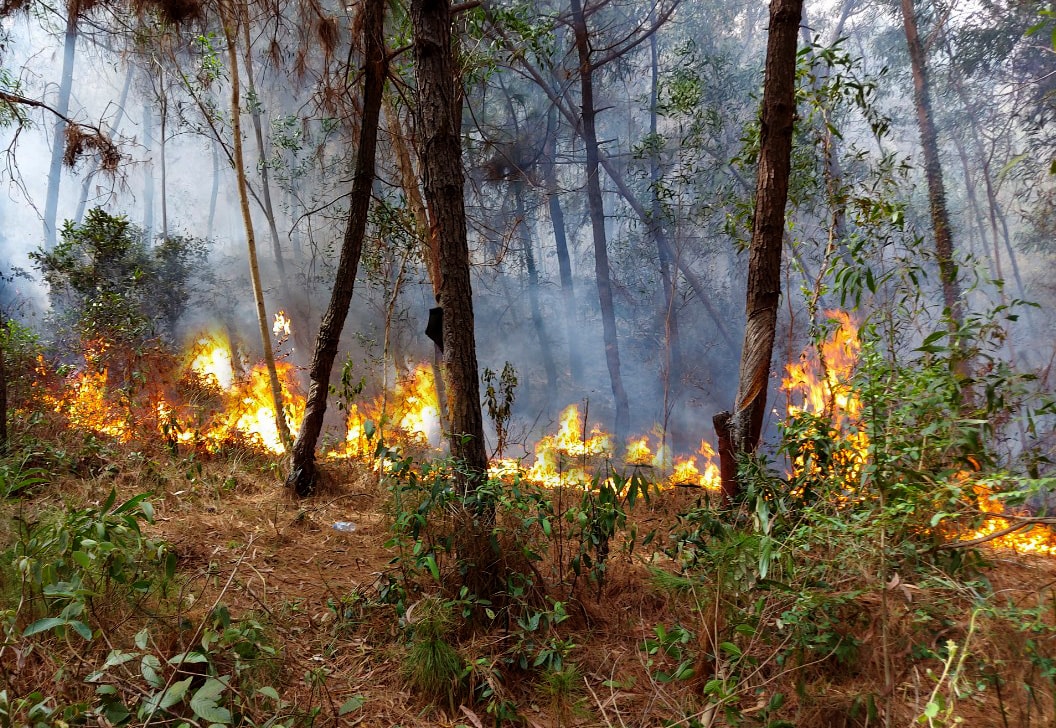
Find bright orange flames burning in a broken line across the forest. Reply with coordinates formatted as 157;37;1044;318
28;312;1056;555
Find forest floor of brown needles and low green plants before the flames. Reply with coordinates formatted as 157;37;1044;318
0;437;1056;728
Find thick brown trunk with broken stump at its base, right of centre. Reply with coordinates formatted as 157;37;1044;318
715;0;803;500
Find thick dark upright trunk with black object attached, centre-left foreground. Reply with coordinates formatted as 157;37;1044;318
411;0;488;477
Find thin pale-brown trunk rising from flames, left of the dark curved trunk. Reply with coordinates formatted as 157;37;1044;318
220;0;290;450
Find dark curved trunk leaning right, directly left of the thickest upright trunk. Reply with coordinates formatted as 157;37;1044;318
286;2;388;496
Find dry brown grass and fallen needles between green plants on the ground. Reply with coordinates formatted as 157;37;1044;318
0;418;1056;728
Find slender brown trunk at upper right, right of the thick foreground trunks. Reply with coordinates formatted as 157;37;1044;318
902;0;964;328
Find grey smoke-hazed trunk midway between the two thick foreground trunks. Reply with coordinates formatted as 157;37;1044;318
571;0;630;447
